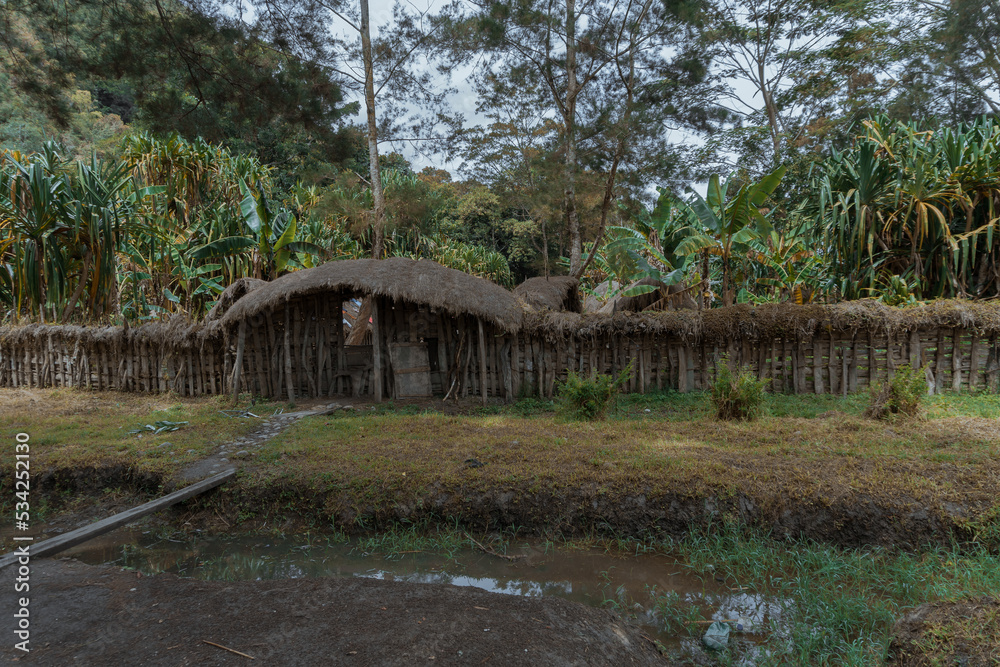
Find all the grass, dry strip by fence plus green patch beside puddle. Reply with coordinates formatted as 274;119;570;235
0;390;1000;665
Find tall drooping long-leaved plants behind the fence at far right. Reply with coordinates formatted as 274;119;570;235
814;117;1000;302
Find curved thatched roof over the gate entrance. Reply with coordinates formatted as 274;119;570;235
221;257;524;332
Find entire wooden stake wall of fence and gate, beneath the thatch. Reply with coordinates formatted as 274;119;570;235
0;316;1000;400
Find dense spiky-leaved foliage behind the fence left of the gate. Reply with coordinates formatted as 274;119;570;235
0;133;332;321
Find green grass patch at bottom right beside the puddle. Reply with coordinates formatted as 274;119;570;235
640;526;1000;665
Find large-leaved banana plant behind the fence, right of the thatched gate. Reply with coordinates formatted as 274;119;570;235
675;166;785;306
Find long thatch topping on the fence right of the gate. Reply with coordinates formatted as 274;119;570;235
524;299;1000;341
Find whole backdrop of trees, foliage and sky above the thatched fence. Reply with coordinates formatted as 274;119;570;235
0;0;1000;321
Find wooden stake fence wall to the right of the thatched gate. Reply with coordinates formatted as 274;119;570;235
509;328;1000;397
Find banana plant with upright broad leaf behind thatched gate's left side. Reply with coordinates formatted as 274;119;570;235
190;180;323;280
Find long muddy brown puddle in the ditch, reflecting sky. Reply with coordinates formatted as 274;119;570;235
11;528;781;656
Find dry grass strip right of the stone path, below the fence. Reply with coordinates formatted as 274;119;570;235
236;394;1000;541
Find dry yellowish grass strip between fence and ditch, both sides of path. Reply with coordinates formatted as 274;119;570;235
7;390;1000;543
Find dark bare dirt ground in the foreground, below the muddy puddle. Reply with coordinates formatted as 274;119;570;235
0;560;664;667
